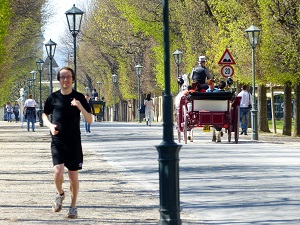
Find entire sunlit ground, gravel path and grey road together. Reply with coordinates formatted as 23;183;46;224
0;122;300;225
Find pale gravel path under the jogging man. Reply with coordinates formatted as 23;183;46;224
0;122;159;225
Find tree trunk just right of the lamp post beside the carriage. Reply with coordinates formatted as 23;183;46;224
257;85;270;132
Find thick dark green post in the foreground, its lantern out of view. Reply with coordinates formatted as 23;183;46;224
156;0;182;225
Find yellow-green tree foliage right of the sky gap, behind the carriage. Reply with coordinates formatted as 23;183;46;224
72;0;300;104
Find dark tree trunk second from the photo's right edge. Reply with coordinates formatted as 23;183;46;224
282;83;292;136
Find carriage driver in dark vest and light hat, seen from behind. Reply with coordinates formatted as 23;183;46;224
192;56;211;90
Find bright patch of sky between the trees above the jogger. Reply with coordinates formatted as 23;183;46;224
43;0;88;67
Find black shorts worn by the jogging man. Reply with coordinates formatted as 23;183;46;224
51;138;83;171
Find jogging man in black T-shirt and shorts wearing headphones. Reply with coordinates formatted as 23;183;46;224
42;67;92;218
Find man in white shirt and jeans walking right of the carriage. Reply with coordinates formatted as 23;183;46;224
237;85;252;135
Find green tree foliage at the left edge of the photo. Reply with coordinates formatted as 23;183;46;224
0;0;45;104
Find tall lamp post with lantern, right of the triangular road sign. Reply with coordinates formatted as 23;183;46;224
245;25;260;140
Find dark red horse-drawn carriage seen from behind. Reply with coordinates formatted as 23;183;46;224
177;91;240;144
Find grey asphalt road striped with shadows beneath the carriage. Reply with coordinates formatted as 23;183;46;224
83;123;300;225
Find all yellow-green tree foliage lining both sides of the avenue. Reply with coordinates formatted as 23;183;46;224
0;0;300;105
